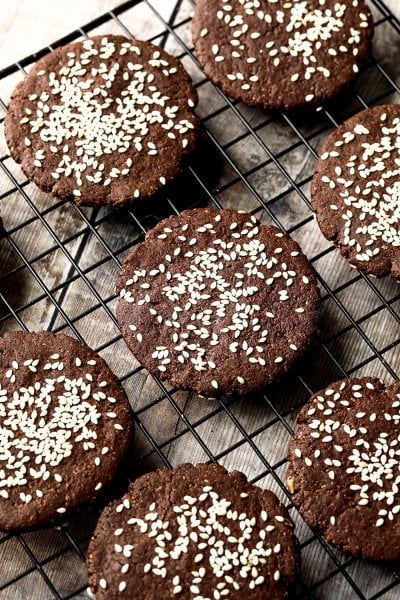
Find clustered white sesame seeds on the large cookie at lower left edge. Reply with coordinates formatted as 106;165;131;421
0;338;126;506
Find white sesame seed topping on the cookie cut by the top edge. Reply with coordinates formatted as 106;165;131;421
208;0;368;102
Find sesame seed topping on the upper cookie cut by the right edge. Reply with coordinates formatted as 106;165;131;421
320;106;400;269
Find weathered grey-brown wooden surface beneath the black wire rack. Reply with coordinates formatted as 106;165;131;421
0;0;400;600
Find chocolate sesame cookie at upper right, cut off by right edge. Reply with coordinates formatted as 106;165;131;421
311;104;400;279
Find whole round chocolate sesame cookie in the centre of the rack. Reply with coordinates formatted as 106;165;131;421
117;208;319;396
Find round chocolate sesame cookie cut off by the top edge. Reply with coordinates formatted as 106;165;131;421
192;0;374;109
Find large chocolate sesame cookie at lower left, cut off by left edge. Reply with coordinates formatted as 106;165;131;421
0;332;132;531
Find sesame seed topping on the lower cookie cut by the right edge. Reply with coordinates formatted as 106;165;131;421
293;379;400;527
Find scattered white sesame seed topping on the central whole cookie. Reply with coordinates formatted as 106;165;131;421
119;211;313;395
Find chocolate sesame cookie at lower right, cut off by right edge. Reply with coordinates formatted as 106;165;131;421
288;377;400;561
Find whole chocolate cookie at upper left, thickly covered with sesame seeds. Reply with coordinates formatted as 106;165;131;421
5;35;199;207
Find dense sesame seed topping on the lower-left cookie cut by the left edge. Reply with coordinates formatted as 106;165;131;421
0;334;127;514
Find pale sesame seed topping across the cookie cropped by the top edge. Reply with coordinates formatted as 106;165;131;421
195;0;369;102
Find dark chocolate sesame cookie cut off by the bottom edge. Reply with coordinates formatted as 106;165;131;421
87;464;300;600
